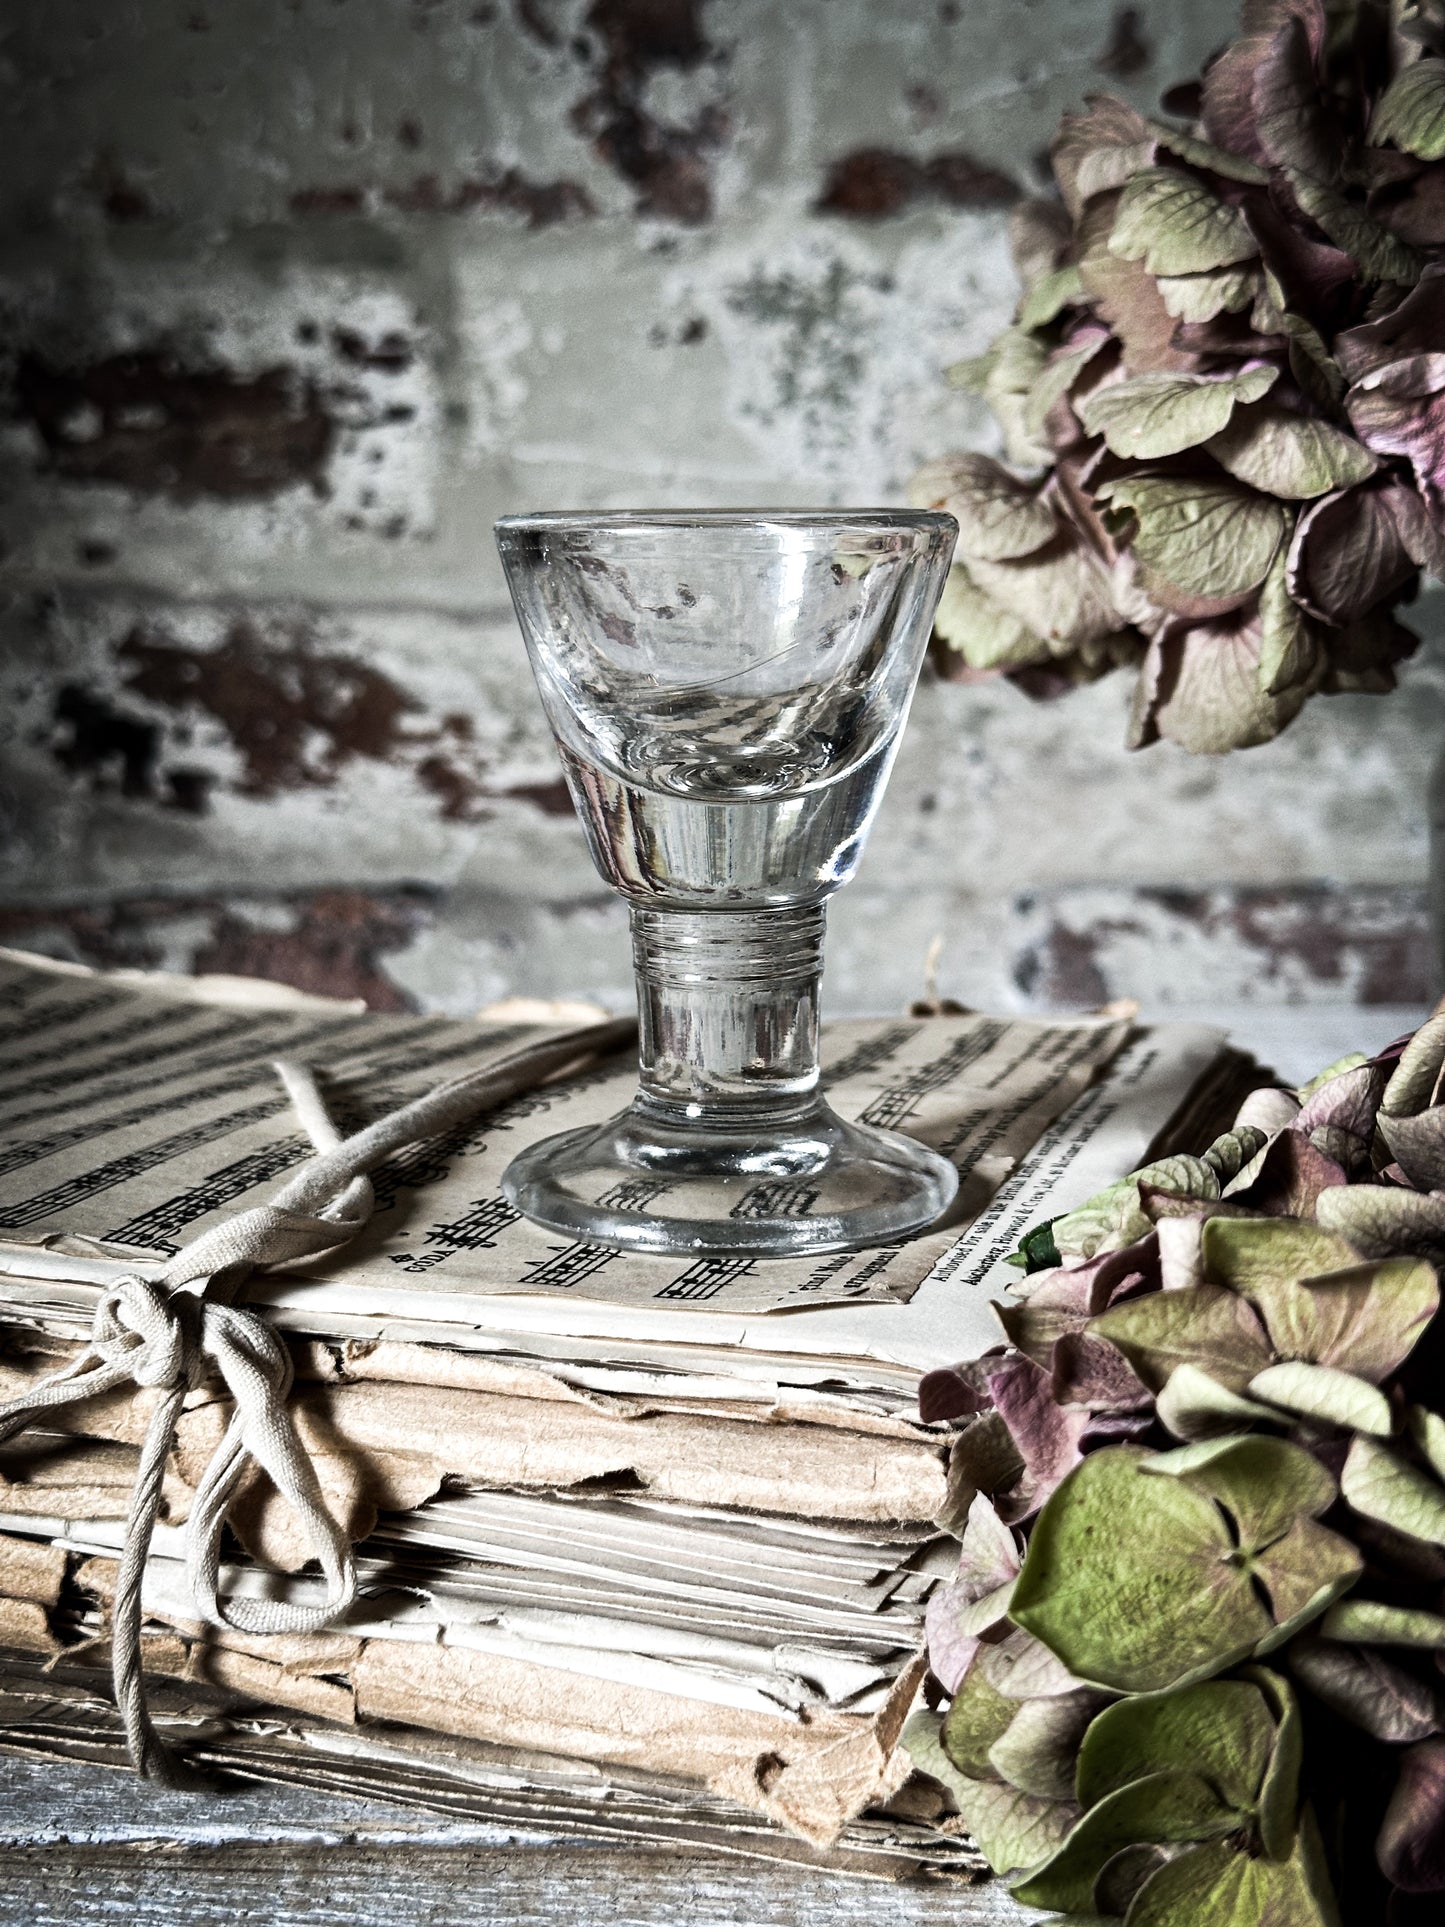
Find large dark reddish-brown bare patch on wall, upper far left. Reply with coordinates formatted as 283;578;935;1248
13;351;335;501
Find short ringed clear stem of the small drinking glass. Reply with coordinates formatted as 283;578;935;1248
632;904;825;1129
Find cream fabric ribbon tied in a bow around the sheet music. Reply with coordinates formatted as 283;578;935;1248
0;1017;636;1786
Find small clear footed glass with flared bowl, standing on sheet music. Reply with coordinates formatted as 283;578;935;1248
497;511;958;1256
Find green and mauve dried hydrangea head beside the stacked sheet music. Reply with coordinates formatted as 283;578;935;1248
917;1008;1445;1927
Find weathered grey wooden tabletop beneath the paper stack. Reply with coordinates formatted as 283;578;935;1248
0;1759;1037;1927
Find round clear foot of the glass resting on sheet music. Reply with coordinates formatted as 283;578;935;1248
501;1098;958;1258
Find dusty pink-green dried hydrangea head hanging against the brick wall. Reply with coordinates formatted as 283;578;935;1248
909;0;1445;753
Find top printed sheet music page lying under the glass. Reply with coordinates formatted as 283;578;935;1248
0;954;1129;1316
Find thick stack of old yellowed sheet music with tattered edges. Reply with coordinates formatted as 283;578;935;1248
0;954;1250;1875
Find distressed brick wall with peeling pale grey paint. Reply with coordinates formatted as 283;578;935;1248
0;0;1445;1010
